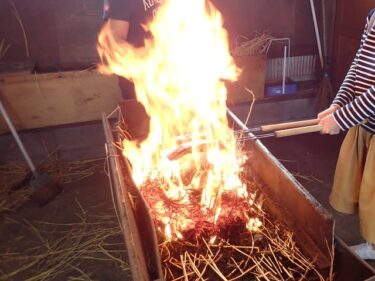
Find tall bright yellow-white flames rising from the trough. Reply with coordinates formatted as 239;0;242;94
98;0;258;237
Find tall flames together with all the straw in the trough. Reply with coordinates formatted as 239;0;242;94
98;0;334;280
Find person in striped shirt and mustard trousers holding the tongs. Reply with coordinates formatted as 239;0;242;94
318;9;375;260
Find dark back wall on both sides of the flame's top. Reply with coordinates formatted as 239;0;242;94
0;0;320;71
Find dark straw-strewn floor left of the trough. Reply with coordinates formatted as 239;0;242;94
0;171;132;281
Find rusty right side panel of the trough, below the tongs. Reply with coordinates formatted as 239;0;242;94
230;108;333;268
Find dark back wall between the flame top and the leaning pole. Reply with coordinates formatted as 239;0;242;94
214;0;320;54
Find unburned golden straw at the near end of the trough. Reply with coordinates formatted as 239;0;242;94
159;222;331;281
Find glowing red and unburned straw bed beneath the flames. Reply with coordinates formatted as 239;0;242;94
141;154;333;281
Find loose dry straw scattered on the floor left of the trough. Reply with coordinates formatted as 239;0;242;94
0;201;129;281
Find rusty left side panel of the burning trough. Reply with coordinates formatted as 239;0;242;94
102;115;162;281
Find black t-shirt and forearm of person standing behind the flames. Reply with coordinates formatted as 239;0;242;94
107;0;163;46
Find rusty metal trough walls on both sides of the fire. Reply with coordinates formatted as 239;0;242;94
102;101;375;281
